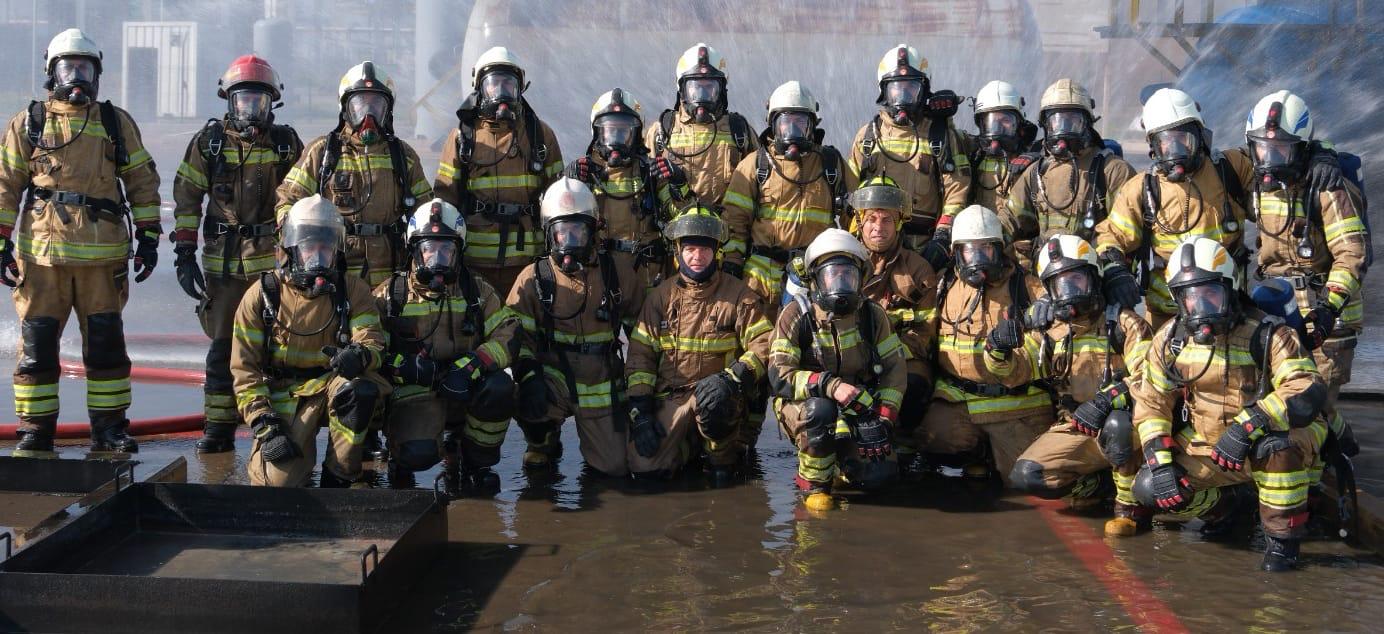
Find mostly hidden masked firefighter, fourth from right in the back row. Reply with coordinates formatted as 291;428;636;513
965;80;1038;214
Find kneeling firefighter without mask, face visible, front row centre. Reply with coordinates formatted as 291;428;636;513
628;203;774;486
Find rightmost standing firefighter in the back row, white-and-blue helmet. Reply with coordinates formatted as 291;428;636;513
1244;90;1370;480
